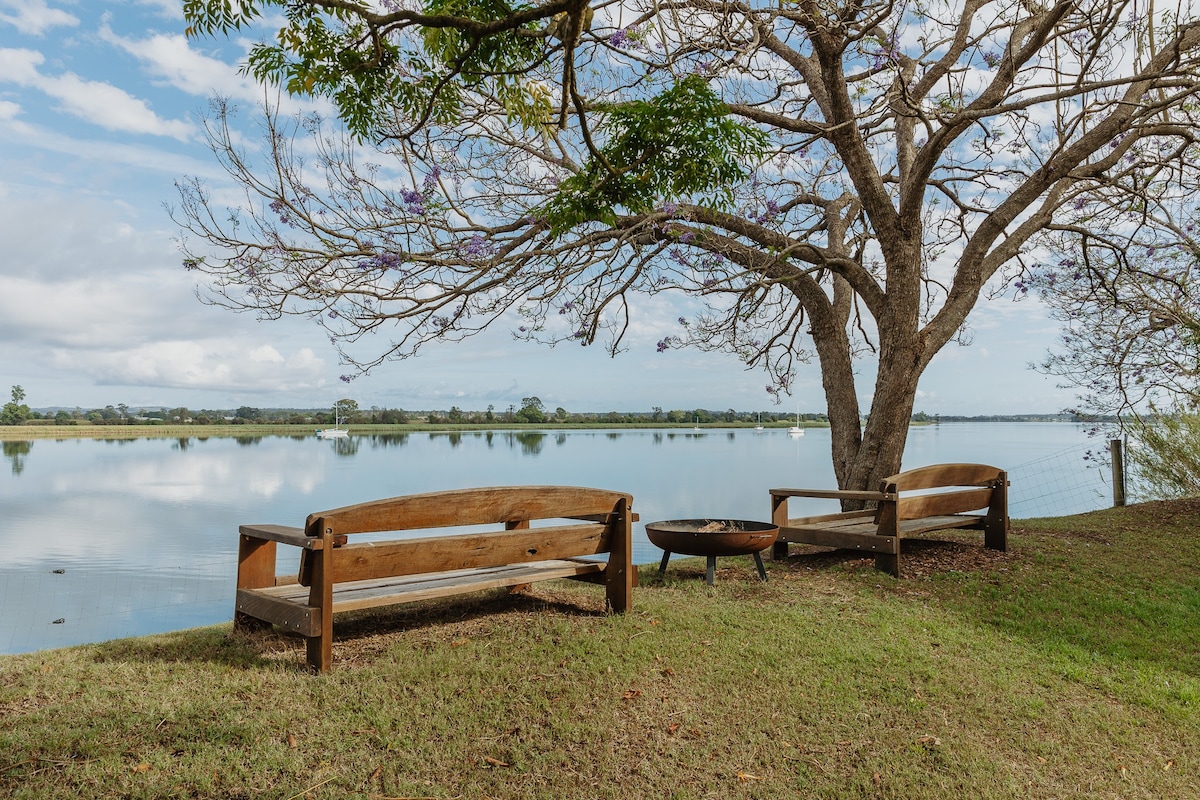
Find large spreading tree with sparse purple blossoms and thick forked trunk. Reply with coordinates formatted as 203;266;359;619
176;0;1200;488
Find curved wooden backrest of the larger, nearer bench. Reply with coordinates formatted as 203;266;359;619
299;486;632;585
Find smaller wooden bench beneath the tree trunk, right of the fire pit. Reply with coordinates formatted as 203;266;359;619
770;464;1008;577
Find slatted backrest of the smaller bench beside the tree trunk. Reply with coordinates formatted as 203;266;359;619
880;464;1008;521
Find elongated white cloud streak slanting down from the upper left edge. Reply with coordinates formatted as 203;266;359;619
0;48;196;142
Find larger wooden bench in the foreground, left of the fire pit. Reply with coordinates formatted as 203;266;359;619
234;486;635;672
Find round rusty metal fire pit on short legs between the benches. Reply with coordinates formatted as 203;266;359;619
646;519;779;585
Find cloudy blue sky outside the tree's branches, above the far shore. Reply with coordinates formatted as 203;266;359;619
0;0;1074;415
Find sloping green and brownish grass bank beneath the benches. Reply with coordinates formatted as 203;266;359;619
0;501;1200;800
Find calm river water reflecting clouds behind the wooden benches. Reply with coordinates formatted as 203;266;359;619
0;423;1111;654
